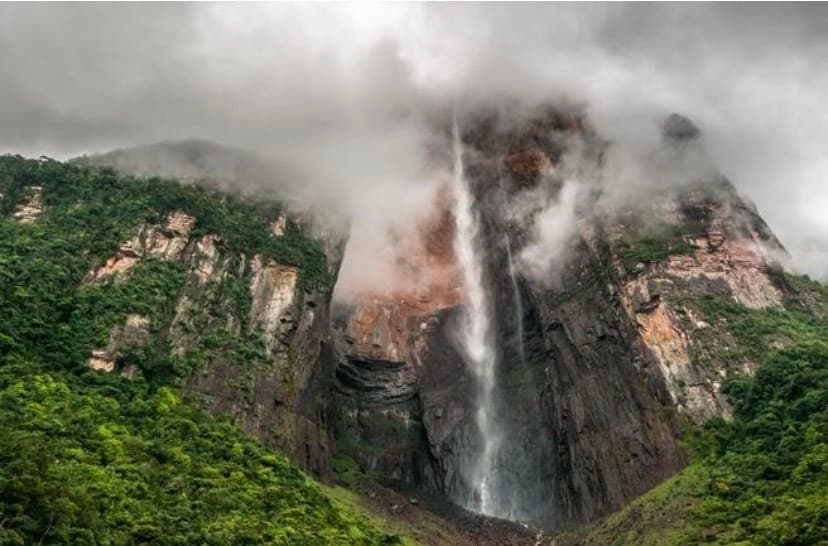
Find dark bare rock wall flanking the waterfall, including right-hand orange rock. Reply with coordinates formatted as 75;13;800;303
335;106;784;527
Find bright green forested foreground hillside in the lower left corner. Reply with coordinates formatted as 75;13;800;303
0;364;396;545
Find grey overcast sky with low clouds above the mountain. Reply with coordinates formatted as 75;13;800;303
0;3;828;276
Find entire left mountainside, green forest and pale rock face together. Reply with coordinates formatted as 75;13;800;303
0;156;402;546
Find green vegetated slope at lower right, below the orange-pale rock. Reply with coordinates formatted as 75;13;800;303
589;277;828;545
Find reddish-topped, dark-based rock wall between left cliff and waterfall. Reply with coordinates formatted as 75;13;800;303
334;195;460;484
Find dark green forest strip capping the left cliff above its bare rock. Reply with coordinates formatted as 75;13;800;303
0;156;333;288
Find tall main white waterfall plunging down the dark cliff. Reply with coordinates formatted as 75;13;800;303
452;116;501;516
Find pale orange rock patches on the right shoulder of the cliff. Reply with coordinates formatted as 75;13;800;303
621;180;784;424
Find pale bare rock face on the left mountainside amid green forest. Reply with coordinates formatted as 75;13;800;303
86;206;340;475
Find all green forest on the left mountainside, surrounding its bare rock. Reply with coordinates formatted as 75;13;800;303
0;156;398;545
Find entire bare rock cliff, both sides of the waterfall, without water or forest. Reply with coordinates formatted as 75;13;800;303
77;118;789;528
